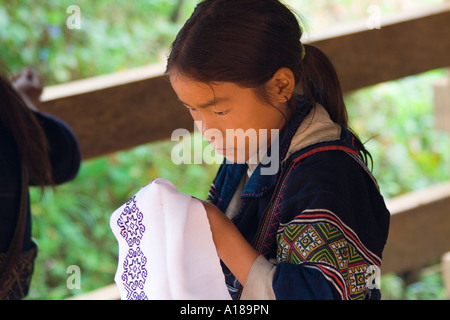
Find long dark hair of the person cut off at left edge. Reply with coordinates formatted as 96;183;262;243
0;75;53;187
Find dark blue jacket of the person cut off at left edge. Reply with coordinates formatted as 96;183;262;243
0;113;81;253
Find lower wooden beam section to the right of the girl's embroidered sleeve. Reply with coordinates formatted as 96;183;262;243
381;183;450;273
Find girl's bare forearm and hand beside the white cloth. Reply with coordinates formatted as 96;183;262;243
202;201;258;285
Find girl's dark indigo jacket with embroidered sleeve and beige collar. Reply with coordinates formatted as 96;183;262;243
208;96;390;299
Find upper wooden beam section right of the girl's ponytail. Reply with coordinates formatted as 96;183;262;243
310;4;450;92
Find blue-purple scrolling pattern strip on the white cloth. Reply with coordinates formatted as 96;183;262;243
117;196;148;300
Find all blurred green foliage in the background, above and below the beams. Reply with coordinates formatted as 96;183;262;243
0;0;450;299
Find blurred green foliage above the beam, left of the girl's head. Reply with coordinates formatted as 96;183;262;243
0;0;194;85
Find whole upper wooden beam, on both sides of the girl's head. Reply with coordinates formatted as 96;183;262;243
39;6;450;159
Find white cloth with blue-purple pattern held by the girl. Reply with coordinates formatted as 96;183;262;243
110;179;231;300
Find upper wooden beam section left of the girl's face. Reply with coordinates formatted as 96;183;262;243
40;66;193;159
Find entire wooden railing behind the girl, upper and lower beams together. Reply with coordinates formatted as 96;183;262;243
36;5;450;298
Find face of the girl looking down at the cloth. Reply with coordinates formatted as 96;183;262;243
170;72;287;162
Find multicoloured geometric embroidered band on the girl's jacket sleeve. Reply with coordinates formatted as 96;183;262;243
277;212;379;299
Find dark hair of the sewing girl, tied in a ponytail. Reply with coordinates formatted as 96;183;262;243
166;0;370;166
